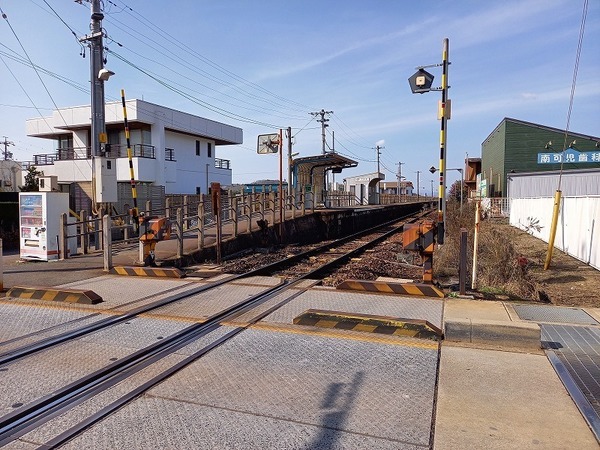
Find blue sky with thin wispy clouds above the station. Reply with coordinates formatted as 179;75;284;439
0;0;600;193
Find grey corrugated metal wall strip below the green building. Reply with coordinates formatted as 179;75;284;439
507;169;600;198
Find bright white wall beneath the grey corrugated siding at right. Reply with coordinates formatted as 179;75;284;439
510;196;600;270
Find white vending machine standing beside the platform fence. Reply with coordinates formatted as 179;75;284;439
19;192;69;261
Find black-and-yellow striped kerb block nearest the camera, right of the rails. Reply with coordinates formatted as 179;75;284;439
294;309;442;341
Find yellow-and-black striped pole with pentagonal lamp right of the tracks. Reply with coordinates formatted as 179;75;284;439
408;38;450;244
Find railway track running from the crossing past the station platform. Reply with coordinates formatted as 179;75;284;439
0;210;426;448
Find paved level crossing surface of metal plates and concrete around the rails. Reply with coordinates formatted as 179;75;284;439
0;247;600;449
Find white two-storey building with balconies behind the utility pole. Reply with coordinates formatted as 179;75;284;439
26;99;243;194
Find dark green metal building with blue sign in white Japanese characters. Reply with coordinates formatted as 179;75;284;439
481;117;600;197
